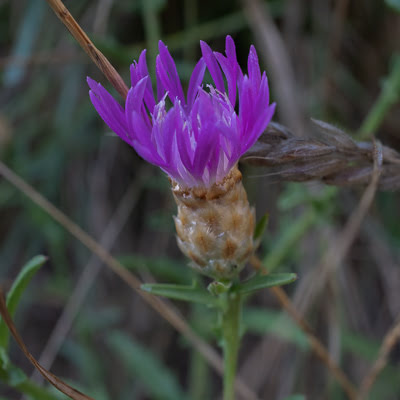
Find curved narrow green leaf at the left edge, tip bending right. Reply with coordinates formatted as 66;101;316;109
0;255;47;348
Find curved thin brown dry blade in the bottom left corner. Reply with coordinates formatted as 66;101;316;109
0;290;94;400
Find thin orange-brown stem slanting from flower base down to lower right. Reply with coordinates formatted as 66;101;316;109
250;256;357;400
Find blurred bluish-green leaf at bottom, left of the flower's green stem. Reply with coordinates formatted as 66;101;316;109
107;331;186;400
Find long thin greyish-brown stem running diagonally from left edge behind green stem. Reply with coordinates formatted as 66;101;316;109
0;161;258;400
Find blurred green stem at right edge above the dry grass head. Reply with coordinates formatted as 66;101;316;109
357;55;400;140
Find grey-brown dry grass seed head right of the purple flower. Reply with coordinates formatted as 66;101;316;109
241;120;400;191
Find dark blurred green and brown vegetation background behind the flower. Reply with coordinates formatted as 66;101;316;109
0;0;400;400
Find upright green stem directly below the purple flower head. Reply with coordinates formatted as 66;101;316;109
222;293;242;400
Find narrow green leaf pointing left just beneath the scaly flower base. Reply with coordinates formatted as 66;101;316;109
141;283;219;305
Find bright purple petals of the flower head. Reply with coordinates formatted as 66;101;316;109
88;36;275;187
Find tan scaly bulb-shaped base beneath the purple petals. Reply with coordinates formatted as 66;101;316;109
171;167;255;279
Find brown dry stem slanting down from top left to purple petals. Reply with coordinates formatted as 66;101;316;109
46;0;128;99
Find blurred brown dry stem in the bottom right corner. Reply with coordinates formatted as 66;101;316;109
357;318;400;400
